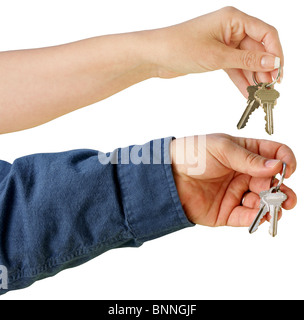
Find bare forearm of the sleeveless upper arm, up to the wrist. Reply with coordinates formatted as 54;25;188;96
0;32;153;133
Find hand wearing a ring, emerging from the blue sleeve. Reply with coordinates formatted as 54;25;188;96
171;134;297;227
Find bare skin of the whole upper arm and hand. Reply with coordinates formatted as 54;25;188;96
0;7;284;133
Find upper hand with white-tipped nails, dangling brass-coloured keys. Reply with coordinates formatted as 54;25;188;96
149;7;284;98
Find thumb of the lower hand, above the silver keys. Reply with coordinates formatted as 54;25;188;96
224;144;283;177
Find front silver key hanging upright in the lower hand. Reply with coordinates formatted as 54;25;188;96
264;187;287;237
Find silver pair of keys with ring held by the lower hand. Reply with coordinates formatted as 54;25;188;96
249;163;287;237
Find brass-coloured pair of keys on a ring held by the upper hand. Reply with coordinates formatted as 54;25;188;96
237;66;281;135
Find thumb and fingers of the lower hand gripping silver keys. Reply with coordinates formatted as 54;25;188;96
207;134;297;227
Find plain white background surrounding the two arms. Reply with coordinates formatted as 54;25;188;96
0;0;304;299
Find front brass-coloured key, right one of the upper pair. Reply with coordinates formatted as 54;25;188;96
255;83;280;135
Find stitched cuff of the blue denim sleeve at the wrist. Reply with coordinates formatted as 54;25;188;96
117;137;194;242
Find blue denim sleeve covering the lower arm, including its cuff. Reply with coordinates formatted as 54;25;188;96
0;138;193;294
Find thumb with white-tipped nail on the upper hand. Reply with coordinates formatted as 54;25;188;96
218;47;281;72
